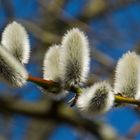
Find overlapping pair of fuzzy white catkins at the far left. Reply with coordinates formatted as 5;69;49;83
0;22;30;87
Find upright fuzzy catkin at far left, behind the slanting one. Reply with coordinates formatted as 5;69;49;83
1;21;30;64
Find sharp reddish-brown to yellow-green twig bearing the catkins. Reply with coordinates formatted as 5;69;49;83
28;75;140;106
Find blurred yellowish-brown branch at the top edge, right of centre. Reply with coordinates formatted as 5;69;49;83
79;0;138;21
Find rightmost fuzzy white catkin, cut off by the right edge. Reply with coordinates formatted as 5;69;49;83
114;52;140;98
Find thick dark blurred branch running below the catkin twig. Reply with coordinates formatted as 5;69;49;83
0;97;115;140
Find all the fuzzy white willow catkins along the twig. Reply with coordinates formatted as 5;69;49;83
0;22;140;115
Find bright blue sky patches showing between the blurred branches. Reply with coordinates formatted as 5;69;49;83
0;0;140;140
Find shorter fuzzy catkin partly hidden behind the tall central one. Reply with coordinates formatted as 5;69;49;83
43;45;61;81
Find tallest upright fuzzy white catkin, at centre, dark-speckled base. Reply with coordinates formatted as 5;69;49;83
60;28;90;86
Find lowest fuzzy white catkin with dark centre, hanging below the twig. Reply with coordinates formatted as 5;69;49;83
76;81;114;115
